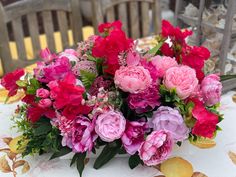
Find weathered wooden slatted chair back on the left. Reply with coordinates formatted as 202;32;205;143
0;0;82;72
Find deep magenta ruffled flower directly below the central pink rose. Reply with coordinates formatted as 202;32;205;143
128;84;160;113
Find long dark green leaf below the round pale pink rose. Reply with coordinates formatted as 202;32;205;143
93;141;121;169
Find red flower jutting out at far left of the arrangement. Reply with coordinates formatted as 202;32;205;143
1;69;25;97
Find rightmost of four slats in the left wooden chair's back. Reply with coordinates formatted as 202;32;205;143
57;11;69;48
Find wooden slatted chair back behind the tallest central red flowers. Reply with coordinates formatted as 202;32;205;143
92;0;161;39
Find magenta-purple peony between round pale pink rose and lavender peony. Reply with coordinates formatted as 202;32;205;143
121;121;148;155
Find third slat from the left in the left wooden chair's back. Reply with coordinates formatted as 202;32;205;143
42;11;56;51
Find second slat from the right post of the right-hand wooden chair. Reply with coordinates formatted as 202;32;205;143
129;2;140;39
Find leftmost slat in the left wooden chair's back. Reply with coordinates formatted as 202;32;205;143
12;17;27;60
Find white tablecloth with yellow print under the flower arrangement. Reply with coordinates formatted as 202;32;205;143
0;92;236;177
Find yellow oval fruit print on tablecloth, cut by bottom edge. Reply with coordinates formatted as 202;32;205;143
161;157;193;177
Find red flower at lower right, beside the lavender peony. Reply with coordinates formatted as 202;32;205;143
191;99;219;138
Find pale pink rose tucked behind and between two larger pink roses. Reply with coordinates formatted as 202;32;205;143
151;55;178;77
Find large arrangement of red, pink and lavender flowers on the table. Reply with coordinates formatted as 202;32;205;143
1;21;225;175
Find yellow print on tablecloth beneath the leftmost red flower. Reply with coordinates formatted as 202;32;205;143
0;89;25;104
